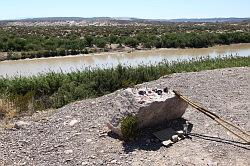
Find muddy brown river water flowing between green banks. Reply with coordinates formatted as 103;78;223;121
0;43;250;77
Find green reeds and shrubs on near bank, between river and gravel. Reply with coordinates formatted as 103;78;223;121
0;56;250;119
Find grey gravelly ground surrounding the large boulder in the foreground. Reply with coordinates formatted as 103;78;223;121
0;67;250;165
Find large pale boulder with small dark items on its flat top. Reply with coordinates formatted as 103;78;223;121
107;88;188;137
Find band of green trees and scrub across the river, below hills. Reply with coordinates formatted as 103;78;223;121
0;24;250;59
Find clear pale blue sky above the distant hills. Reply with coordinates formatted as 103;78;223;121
0;0;250;20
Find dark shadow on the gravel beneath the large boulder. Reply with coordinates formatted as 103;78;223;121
108;118;193;153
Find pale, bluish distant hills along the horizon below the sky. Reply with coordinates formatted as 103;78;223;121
0;17;250;26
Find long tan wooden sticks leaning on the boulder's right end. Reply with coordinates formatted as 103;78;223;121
173;90;250;144
